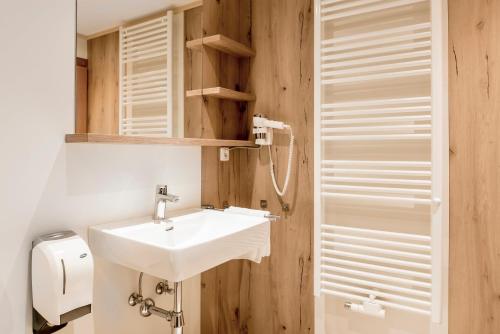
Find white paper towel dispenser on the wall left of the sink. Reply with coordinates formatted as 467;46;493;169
31;231;94;333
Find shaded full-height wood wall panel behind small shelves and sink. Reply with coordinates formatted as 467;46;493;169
197;0;254;333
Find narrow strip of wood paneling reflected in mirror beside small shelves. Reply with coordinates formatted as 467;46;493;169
184;6;203;138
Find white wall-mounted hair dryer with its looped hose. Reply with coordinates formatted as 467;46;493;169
253;115;295;197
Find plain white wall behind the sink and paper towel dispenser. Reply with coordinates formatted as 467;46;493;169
0;0;200;334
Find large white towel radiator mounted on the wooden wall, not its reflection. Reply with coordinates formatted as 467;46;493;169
315;0;448;323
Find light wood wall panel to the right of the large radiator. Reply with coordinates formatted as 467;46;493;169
449;0;500;334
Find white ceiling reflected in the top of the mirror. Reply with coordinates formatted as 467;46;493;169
76;0;193;36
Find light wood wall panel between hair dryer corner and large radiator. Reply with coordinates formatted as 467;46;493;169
242;0;314;333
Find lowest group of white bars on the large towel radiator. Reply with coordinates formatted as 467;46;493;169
320;224;432;315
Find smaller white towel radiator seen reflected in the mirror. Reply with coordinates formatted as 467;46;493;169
119;11;173;137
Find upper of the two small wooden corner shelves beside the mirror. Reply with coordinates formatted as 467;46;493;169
186;34;255;57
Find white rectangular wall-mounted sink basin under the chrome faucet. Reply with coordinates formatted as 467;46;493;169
89;209;270;282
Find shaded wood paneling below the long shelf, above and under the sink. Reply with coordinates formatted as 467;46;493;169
201;148;252;333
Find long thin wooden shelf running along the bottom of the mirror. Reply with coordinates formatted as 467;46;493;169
66;133;257;147
